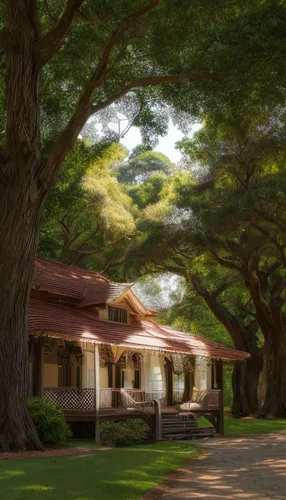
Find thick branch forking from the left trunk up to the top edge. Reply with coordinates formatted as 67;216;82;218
37;0;84;68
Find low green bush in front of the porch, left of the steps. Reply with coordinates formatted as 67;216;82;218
99;419;148;446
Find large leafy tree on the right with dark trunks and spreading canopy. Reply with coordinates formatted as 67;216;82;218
126;116;286;417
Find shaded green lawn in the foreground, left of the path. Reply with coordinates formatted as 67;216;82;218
0;442;197;500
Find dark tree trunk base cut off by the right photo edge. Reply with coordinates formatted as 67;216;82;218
257;332;286;418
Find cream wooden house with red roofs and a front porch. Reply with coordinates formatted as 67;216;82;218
28;258;249;438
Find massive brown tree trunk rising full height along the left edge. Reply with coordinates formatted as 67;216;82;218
0;0;44;450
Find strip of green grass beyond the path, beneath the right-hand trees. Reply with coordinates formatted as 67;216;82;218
199;416;286;436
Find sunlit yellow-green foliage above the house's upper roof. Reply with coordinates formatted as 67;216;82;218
38;141;134;269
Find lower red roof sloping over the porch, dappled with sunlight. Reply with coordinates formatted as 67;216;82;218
29;299;250;359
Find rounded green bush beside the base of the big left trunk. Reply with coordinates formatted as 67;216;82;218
28;398;72;446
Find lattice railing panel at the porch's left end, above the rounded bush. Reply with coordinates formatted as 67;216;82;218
44;387;95;410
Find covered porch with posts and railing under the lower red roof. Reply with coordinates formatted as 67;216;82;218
29;335;226;438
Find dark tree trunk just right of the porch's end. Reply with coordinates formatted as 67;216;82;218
231;355;263;418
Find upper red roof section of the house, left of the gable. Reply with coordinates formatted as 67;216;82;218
33;257;131;307
